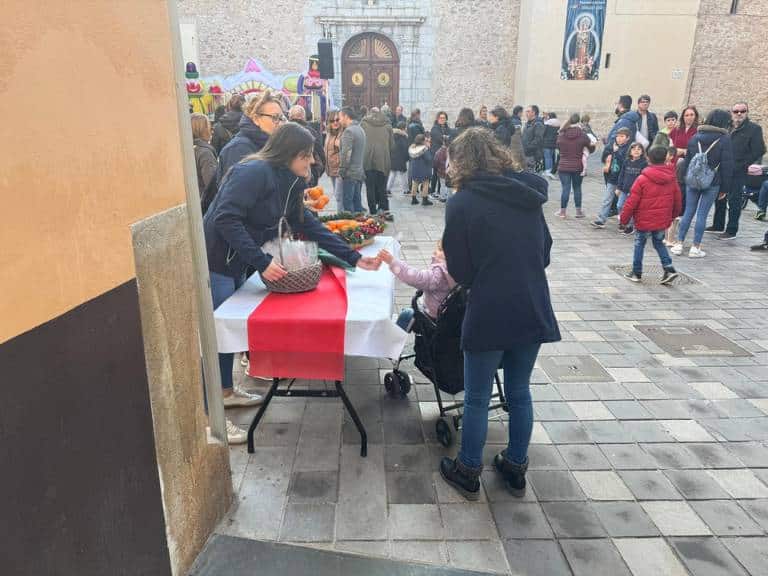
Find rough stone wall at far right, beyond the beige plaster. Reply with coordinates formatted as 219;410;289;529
688;0;768;124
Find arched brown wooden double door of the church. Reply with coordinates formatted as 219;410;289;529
341;32;400;110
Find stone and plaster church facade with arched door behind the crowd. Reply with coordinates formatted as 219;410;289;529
177;0;768;125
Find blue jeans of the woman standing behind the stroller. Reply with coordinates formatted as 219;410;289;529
459;344;541;468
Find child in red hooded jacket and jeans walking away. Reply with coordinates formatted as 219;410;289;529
620;146;682;284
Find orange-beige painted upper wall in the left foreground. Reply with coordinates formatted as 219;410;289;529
0;0;189;342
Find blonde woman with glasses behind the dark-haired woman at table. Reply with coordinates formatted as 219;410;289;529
216;90;285;187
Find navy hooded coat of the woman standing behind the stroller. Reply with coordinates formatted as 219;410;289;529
443;172;560;351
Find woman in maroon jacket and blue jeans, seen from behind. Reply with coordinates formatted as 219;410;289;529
556;114;595;218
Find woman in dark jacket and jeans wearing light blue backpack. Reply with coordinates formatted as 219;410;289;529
670;110;734;258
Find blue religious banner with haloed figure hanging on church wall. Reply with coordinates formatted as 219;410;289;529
560;0;606;80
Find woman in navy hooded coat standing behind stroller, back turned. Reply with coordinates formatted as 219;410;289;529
440;128;560;500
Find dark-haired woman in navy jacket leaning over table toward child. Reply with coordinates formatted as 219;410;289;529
203;123;379;438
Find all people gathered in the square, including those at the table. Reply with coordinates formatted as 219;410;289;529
192;91;768;500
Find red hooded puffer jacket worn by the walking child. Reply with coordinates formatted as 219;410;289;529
621;164;683;232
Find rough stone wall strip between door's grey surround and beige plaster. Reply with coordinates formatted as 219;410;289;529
428;0;520;122
